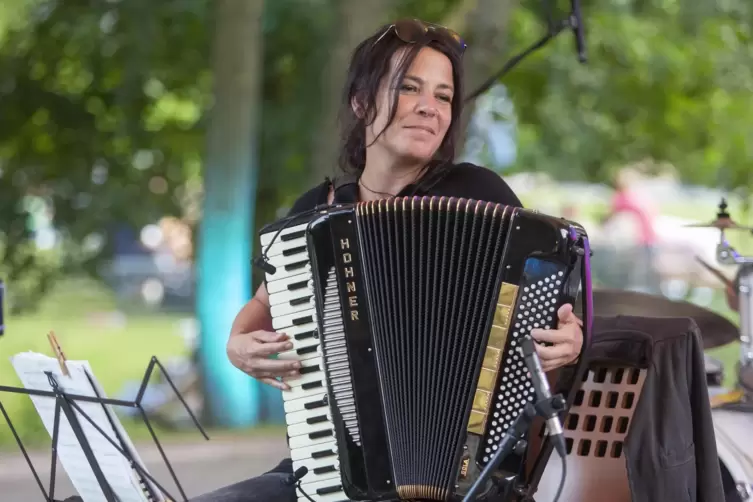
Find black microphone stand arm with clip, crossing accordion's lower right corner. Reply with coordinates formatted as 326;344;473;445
463;394;566;502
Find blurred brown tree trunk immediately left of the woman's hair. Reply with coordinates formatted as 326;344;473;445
311;0;392;184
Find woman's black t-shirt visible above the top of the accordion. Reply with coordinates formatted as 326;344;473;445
290;163;523;215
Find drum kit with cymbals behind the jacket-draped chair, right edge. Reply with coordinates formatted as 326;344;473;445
593;200;753;502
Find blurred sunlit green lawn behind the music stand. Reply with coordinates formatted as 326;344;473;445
0;280;284;452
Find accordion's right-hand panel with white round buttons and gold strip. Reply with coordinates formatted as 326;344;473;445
458;209;579;493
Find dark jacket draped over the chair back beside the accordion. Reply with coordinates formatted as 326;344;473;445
588;316;724;502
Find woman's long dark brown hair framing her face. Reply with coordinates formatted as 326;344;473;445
339;24;463;173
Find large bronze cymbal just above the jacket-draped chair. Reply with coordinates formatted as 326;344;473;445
575;289;740;350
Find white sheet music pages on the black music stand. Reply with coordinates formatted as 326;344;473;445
11;352;165;502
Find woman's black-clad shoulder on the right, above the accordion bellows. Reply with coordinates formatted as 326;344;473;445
437;162;522;207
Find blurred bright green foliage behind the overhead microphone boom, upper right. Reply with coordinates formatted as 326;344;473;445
505;0;753;188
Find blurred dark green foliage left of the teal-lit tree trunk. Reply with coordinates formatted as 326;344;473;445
0;0;209;309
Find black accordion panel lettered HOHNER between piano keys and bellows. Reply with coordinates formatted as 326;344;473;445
309;209;393;500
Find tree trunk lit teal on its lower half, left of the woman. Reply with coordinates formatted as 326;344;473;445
196;0;264;427
